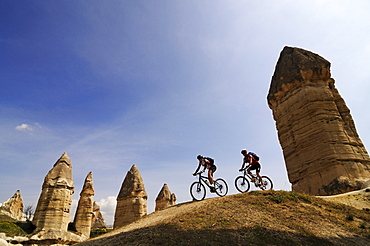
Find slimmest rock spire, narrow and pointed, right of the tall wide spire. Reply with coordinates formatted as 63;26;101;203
74;172;94;238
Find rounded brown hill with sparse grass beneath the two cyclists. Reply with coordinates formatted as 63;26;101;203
78;191;370;246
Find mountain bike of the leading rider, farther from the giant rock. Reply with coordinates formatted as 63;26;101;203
190;172;229;201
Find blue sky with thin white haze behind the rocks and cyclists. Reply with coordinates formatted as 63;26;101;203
0;0;370;224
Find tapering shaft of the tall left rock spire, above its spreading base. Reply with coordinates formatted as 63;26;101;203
32;153;74;232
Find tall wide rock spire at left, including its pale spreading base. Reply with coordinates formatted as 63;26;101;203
27;153;87;245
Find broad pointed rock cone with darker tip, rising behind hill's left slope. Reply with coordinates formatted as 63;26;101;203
113;165;148;229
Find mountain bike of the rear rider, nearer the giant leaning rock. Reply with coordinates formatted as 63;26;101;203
235;168;273;193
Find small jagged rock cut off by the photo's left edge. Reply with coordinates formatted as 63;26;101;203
0;190;23;220
